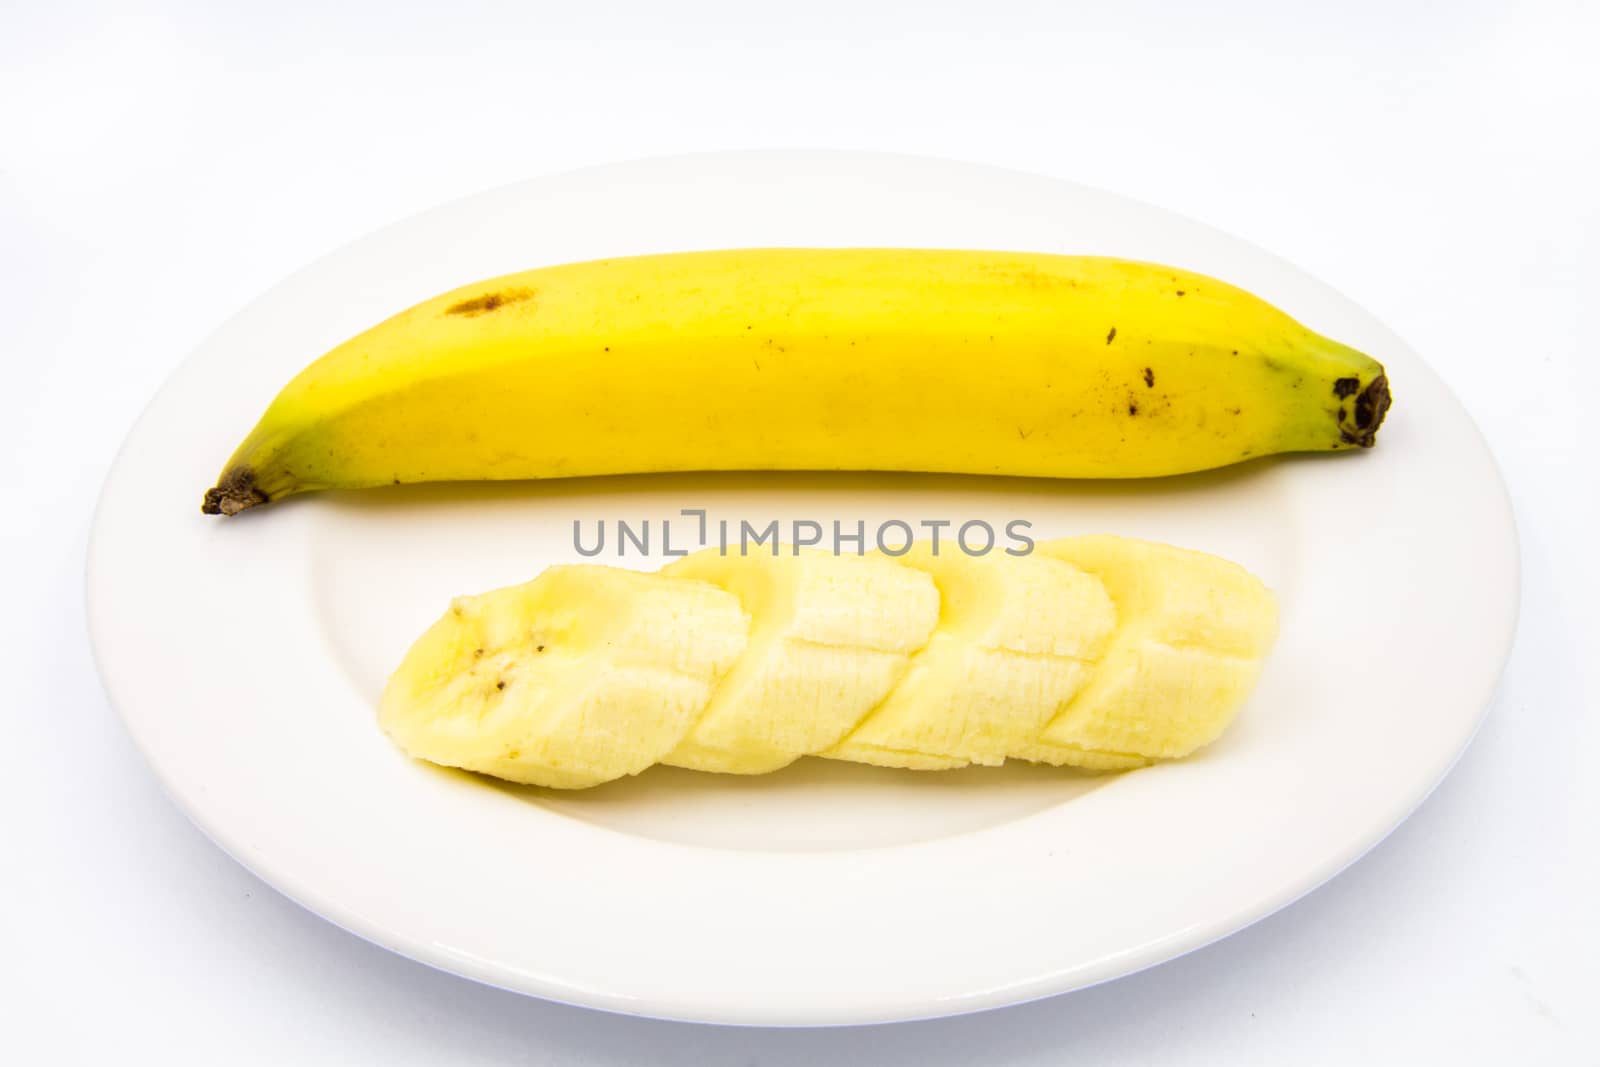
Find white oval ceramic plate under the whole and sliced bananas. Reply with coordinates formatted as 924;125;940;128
90;154;1517;1024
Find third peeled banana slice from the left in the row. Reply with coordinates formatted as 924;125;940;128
822;545;1117;769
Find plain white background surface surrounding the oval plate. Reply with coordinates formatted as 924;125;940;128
0;0;1600;1065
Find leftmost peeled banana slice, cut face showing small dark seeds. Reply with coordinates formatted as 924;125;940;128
379;566;749;789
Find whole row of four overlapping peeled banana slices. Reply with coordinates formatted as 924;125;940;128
379;536;1277;789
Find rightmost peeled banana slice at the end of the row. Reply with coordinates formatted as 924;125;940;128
1014;536;1277;769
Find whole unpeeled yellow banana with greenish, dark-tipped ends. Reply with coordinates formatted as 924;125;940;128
202;248;1389;515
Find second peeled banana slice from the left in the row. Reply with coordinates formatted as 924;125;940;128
662;549;939;774
